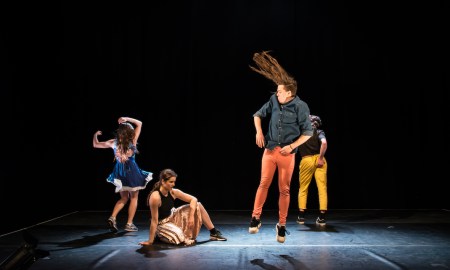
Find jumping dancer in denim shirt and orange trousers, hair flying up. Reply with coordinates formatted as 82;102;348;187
249;52;313;243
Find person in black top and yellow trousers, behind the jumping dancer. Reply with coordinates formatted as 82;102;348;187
297;115;328;226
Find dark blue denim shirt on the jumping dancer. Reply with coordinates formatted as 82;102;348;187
253;94;313;153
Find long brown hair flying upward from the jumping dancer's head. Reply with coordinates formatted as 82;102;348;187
250;51;297;95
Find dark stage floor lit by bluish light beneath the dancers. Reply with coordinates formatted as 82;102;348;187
0;209;450;270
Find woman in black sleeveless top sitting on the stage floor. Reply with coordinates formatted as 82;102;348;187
139;169;227;246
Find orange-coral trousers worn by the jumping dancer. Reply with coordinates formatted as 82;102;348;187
252;147;295;225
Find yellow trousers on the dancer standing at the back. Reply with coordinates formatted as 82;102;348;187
298;154;328;211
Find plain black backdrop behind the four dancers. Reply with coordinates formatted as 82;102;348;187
0;0;449;232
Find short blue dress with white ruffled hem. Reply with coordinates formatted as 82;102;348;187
106;142;153;193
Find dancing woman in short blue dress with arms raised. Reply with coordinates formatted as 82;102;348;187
93;117;153;232
